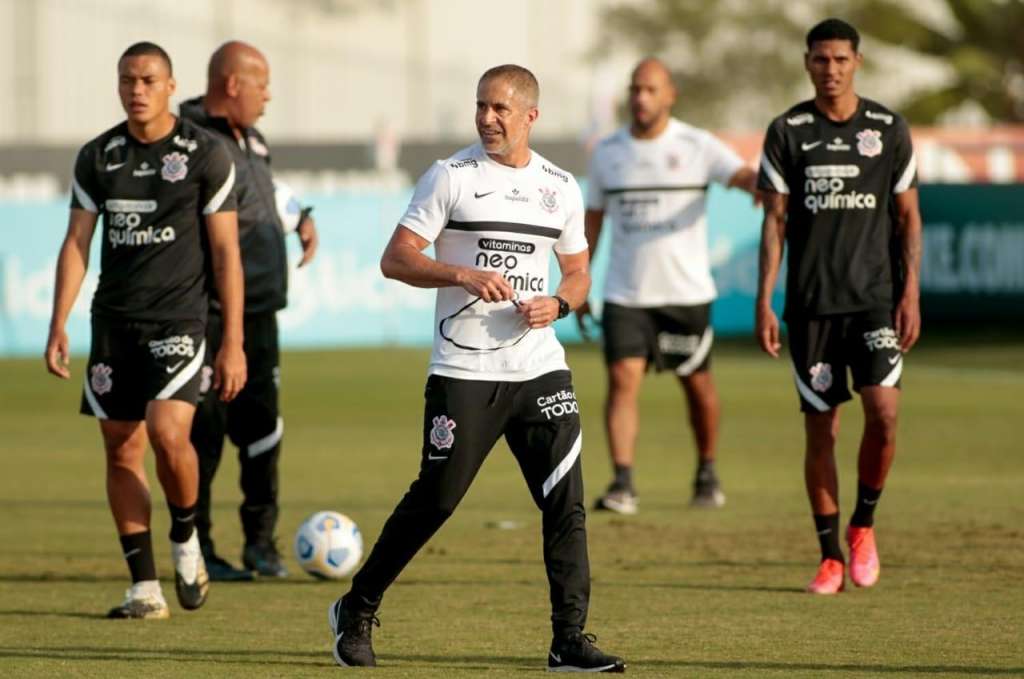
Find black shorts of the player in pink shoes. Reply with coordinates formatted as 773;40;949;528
785;310;903;413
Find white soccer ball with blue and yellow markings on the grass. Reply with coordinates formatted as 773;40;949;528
295;512;362;580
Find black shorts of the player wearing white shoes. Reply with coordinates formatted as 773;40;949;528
81;316;206;421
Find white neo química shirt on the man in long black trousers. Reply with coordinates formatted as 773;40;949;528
399;143;587;382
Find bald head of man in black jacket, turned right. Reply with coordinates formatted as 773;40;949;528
205;40;270;129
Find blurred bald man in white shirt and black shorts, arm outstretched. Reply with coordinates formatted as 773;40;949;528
577;59;757;514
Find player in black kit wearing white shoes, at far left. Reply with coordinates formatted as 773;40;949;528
45;42;246;619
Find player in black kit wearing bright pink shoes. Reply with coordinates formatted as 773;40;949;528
756;18;922;594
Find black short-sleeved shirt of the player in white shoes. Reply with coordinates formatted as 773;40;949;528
71;119;236;321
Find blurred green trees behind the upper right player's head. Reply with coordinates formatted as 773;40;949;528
601;0;1024;127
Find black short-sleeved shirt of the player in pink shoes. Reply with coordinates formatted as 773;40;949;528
758;98;918;319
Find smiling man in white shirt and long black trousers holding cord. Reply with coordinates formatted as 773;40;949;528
329;65;625;672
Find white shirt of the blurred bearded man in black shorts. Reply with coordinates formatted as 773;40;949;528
587;118;743;306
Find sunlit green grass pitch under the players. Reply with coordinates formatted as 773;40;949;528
0;337;1024;678
